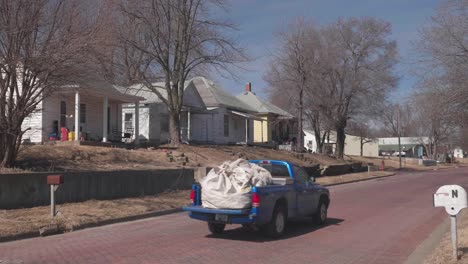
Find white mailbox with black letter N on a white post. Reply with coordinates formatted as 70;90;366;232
434;185;468;260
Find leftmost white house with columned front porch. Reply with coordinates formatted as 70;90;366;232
22;81;143;143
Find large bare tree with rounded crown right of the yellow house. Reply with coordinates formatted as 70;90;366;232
267;18;397;159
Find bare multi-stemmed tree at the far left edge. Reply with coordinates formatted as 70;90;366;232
0;0;98;167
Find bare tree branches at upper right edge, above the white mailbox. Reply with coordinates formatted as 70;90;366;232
415;0;468;119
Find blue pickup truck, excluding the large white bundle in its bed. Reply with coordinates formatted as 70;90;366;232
183;160;330;238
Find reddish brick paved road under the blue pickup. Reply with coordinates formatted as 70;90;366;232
0;168;468;264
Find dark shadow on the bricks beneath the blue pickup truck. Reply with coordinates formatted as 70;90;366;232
206;218;344;243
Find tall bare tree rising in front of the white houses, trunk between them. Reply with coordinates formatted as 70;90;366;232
119;0;246;146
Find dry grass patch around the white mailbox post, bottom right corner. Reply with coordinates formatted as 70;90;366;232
424;210;468;264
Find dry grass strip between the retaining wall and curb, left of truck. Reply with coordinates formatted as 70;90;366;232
0;191;190;238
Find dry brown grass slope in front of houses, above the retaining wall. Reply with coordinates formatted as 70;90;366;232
9;142;344;173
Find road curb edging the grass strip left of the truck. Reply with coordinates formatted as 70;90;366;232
0;207;182;243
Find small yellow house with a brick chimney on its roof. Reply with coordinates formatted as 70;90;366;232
237;83;297;143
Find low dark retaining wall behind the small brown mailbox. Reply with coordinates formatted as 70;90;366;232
0;168;199;209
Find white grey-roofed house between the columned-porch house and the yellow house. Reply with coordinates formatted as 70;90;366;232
122;77;261;144
